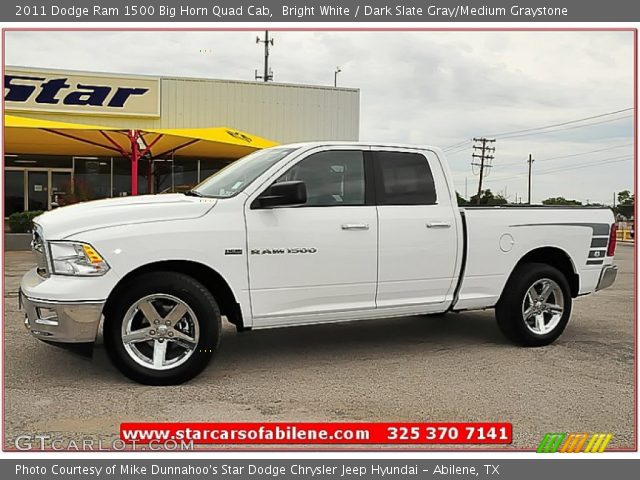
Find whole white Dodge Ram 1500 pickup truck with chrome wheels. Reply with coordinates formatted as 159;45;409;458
19;142;617;385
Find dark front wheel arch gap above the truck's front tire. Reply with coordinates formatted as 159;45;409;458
103;260;244;328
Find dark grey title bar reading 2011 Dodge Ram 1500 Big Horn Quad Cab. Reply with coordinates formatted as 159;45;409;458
0;0;640;24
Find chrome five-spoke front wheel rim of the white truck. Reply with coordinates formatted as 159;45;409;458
122;293;200;370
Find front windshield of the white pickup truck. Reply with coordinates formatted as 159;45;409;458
187;147;295;198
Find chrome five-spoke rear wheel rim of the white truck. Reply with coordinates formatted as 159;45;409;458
522;278;564;335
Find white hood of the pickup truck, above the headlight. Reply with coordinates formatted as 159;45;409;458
34;193;217;240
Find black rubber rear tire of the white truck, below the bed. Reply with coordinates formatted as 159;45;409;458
495;263;572;347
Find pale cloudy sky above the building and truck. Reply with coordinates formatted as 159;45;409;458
5;31;634;203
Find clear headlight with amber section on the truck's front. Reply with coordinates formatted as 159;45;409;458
49;242;109;276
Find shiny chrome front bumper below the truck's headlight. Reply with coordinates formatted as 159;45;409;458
18;291;104;343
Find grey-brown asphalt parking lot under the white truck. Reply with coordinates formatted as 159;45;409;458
4;245;634;449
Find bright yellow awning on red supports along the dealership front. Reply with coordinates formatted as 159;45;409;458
4;115;277;159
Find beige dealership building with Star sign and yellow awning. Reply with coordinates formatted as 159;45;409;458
4;67;360;217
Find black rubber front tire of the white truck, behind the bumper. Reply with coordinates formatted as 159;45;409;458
104;272;222;385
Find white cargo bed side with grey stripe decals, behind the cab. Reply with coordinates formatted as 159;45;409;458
453;206;612;310
